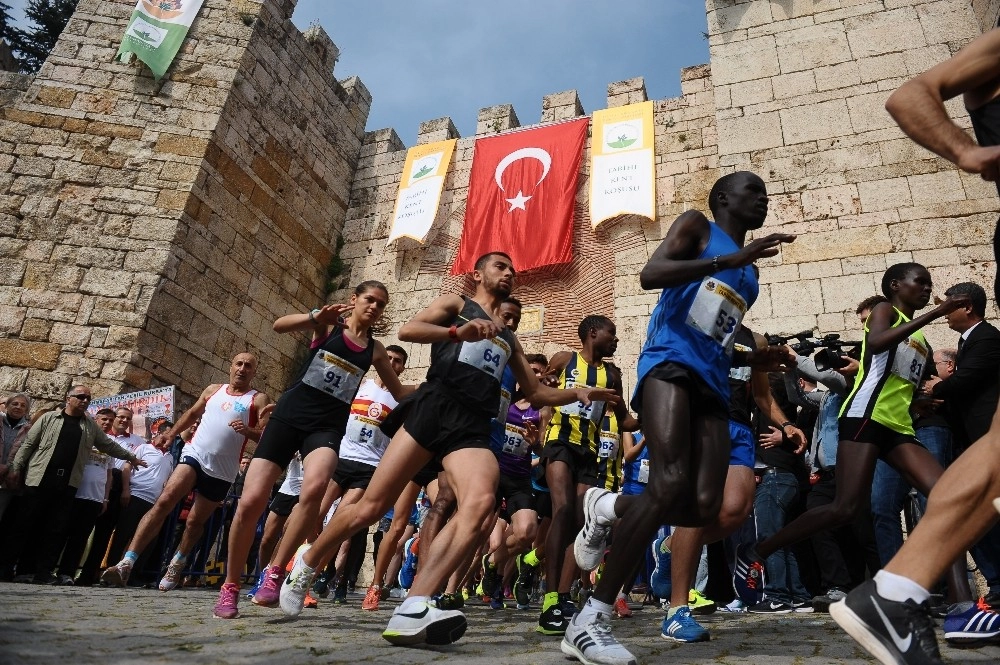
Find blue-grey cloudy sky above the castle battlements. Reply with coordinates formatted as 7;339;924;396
6;0;708;145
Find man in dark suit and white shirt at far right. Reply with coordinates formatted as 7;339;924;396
924;282;1000;607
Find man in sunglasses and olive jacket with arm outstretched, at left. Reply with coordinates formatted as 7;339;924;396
0;386;146;583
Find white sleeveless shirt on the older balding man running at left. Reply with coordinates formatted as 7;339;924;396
181;383;257;483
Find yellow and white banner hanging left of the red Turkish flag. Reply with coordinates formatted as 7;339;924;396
386;139;458;244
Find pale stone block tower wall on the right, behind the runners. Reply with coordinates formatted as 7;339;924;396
706;0;998;346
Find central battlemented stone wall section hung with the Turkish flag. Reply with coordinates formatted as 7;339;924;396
334;65;718;392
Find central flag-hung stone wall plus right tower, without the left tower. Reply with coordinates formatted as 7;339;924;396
337;0;1000;390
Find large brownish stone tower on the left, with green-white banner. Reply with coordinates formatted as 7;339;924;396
0;0;370;400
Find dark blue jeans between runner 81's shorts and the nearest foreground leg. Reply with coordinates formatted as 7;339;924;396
872;427;952;566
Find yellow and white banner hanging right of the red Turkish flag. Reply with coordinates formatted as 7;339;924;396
590;102;656;228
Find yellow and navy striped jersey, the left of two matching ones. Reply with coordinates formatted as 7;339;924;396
545;352;614;454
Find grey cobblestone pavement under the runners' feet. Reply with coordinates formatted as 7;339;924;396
0;584;1000;665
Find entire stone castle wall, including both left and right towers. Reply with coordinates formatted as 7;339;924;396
0;0;1000;408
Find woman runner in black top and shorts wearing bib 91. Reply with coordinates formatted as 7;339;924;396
215;280;413;618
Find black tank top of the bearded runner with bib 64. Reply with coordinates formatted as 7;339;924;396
427;296;514;418
